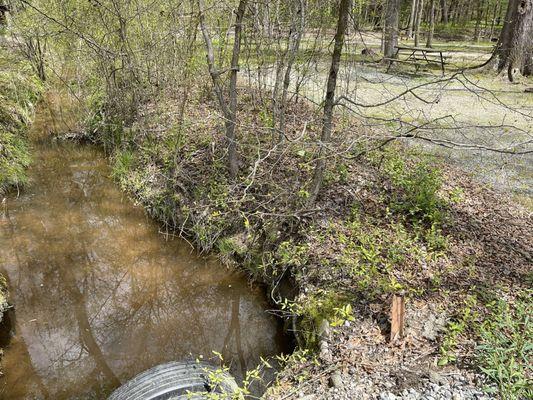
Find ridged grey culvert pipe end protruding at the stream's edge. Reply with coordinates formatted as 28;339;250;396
108;361;238;400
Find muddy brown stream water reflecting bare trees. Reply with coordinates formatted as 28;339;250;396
0;143;287;400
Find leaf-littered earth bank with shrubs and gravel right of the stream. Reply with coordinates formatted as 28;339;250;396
85;79;533;399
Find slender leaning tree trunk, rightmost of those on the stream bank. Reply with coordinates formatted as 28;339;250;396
308;0;352;204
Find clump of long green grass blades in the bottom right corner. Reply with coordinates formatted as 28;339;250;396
477;291;533;399
